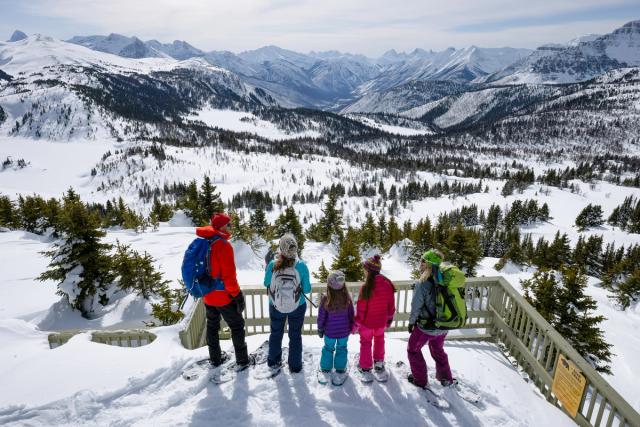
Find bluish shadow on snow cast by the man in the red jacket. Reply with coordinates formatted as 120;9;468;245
189;372;254;427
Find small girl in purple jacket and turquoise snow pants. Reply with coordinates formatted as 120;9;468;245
318;271;355;374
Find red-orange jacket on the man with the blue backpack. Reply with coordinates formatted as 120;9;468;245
196;225;240;307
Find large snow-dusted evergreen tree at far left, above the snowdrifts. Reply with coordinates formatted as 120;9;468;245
38;189;113;318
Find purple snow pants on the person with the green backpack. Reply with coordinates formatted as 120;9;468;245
407;326;453;387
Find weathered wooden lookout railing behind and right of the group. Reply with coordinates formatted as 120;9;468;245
180;277;640;427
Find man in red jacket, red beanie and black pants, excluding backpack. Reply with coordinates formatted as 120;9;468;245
196;213;250;370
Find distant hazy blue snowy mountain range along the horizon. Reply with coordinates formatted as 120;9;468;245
62;21;640;113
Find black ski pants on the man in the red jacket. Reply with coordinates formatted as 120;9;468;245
204;301;249;365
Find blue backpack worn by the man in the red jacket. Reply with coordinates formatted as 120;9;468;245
182;236;224;298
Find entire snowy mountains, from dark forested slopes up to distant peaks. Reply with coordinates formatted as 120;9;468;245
0;21;640;143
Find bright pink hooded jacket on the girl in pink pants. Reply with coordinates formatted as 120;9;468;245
356;274;396;329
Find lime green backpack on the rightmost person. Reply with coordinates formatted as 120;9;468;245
435;265;467;329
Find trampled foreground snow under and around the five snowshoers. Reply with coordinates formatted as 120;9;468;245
0;326;572;426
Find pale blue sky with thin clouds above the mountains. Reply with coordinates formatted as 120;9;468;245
0;0;640;56
